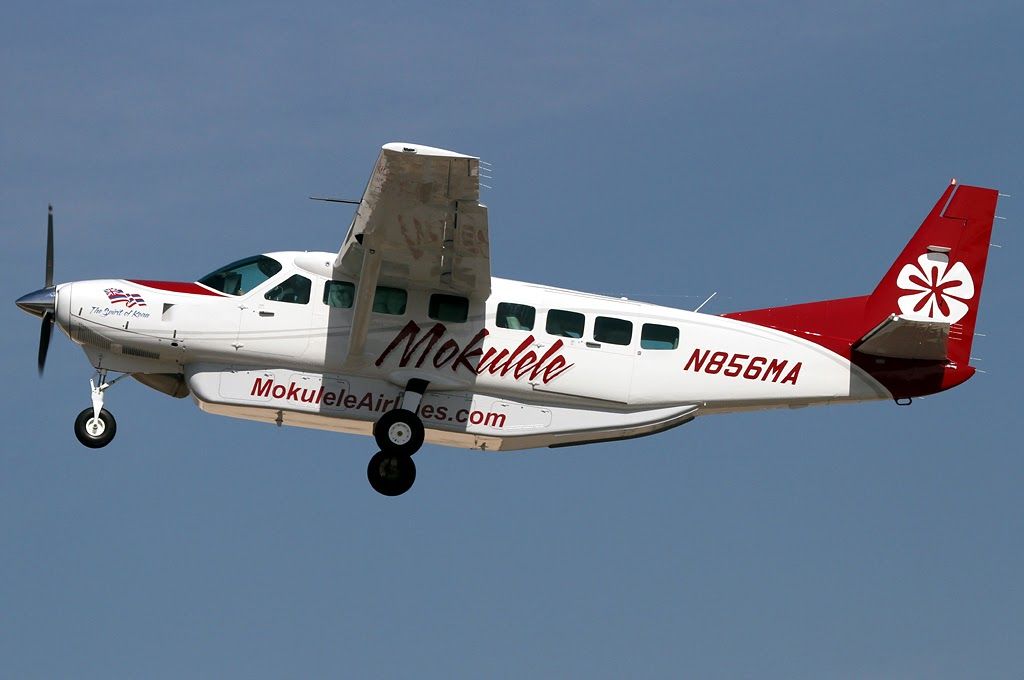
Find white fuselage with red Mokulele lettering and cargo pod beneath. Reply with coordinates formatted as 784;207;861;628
56;253;890;450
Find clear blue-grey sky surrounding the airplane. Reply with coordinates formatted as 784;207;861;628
0;2;1024;678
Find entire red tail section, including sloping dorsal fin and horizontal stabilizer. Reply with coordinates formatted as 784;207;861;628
723;181;998;397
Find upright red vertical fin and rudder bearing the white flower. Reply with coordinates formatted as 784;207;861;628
864;180;998;366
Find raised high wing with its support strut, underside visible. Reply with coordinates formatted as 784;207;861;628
334;142;490;365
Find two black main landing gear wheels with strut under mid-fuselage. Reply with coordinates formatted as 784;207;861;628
367;380;427;496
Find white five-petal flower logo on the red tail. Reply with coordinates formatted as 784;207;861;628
896;253;974;324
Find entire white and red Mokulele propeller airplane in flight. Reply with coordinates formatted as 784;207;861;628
16;142;998;496
